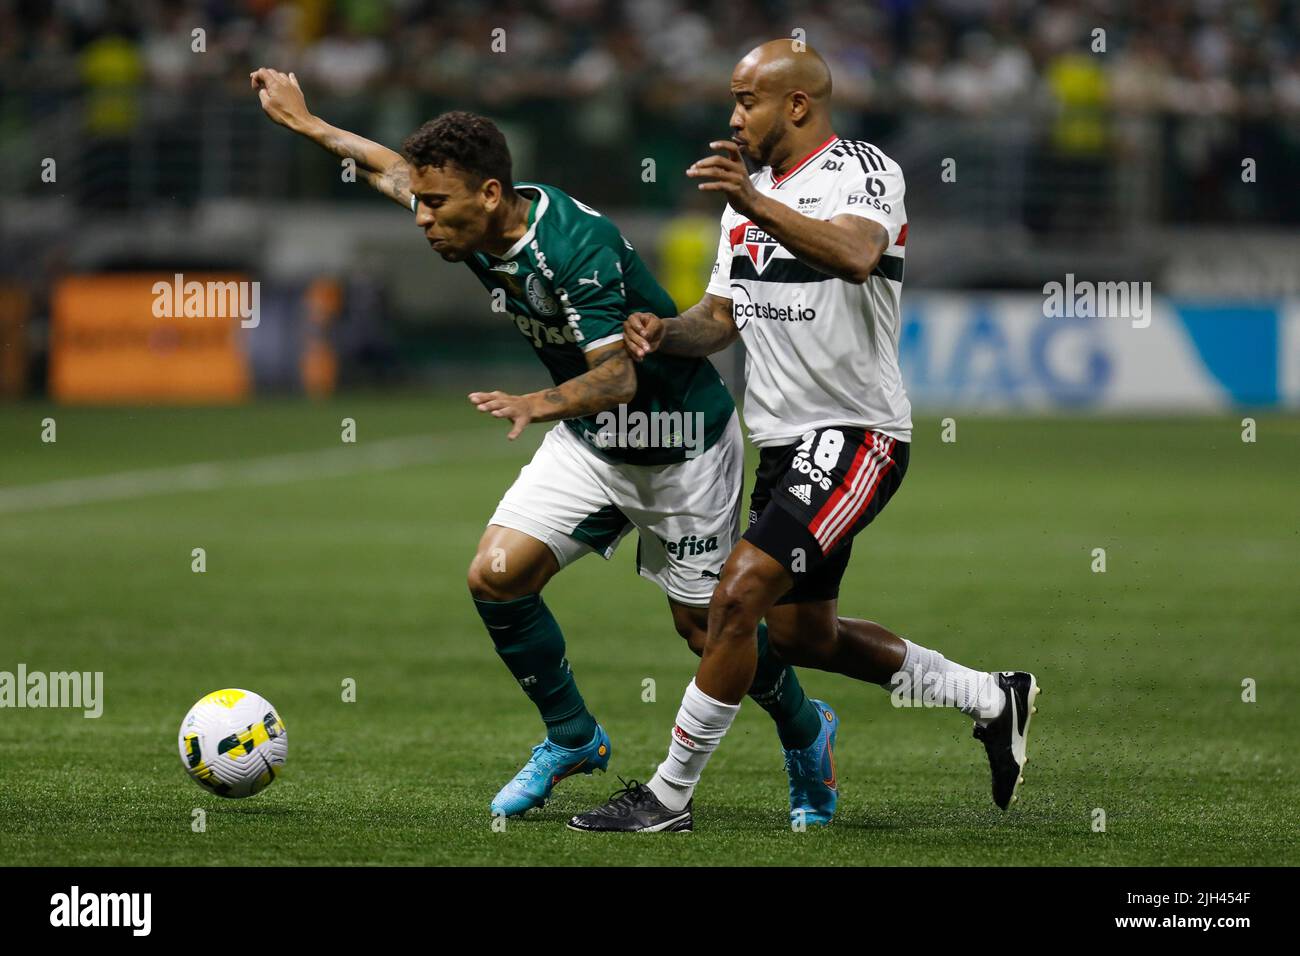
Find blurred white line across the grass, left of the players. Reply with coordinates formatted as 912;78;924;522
0;429;527;514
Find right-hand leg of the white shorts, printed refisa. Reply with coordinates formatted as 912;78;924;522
614;418;745;607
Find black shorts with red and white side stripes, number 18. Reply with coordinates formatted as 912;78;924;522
745;425;910;604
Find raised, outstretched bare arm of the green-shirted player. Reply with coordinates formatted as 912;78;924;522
248;66;411;209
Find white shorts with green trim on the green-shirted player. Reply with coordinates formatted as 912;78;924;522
489;414;745;607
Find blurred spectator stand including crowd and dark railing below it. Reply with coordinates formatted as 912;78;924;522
0;0;1300;232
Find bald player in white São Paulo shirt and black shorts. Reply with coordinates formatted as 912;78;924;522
569;40;1039;832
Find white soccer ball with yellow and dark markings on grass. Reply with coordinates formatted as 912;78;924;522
179;687;289;797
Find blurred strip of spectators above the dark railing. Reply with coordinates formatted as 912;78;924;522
0;0;1300;117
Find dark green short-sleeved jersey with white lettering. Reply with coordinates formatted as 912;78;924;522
465;182;736;464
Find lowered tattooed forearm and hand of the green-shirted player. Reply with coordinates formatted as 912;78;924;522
469;342;637;441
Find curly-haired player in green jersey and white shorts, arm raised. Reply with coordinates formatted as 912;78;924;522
251;69;822;816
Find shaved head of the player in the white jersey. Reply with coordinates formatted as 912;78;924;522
731;39;831;168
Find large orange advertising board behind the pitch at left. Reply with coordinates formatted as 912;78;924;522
49;273;250;402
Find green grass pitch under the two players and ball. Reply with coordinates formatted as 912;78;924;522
0;397;1300;865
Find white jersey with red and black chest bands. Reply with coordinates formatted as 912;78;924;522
709;137;911;446
